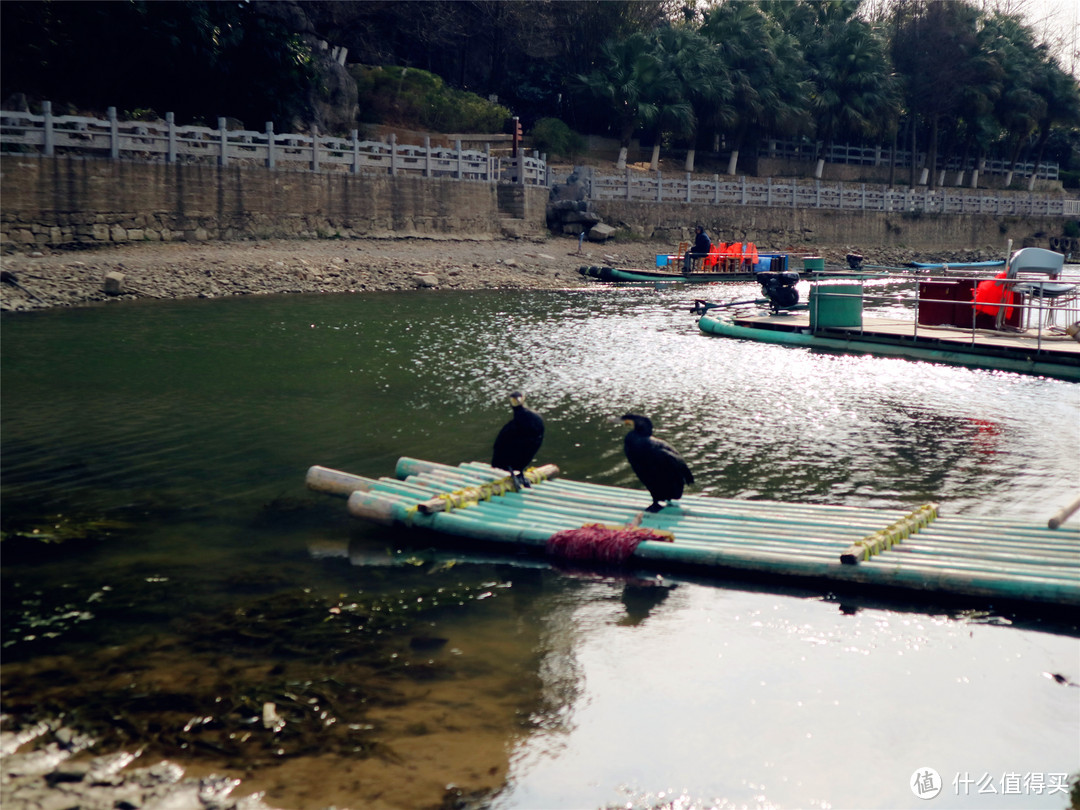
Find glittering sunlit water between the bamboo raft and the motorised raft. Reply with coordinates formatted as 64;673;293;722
393;282;1080;514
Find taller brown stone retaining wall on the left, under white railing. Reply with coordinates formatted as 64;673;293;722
0;156;548;251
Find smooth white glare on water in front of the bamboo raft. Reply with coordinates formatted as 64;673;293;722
495;583;1080;810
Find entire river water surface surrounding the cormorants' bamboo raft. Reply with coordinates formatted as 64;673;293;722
0;285;1080;810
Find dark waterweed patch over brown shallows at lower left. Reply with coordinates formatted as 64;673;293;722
2;582;507;767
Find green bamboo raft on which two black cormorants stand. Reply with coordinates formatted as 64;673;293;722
307;458;1080;607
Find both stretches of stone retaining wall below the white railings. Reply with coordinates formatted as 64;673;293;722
0;156;1068;252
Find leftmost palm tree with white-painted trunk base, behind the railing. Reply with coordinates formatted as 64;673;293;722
576;33;669;168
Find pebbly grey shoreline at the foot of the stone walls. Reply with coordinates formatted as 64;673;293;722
0;238;1000;311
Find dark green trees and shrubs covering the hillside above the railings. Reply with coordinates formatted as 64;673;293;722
0;0;1080;186
